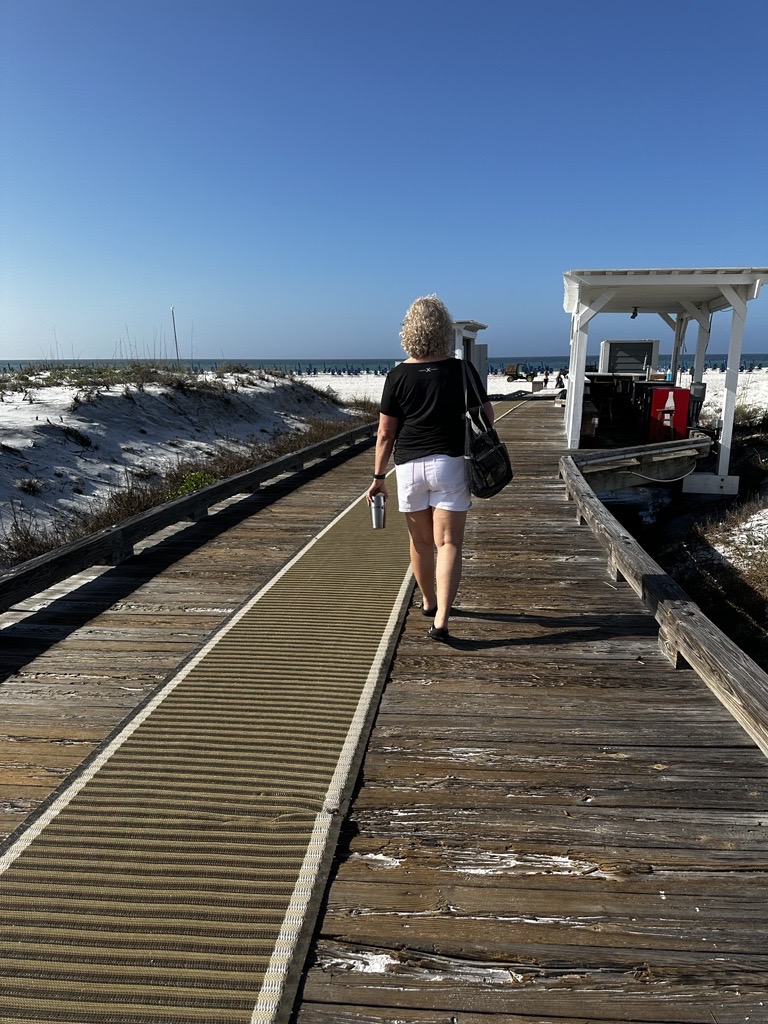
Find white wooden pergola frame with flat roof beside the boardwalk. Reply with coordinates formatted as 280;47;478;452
563;267;768;494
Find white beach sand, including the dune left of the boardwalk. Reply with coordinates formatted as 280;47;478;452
0;370;768;544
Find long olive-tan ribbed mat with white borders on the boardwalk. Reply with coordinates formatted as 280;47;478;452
0;442;413;1024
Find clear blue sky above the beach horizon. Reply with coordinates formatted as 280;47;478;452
0;0;768;359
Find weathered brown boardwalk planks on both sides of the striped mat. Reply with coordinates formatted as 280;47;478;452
0;401;768;1024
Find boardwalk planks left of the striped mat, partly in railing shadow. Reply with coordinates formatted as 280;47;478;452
0;452;385;840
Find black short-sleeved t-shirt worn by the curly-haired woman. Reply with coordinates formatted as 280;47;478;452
381;358;488;466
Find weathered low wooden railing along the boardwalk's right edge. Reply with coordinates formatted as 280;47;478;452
560;456;768;756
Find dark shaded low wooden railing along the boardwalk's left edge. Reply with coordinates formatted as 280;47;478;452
0;423;376;611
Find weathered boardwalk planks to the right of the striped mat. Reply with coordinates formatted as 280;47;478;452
295;402;768;1024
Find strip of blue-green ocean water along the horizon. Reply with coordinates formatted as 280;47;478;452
0;352;768;376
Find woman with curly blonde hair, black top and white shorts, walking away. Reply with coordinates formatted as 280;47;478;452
367;295;494;642
